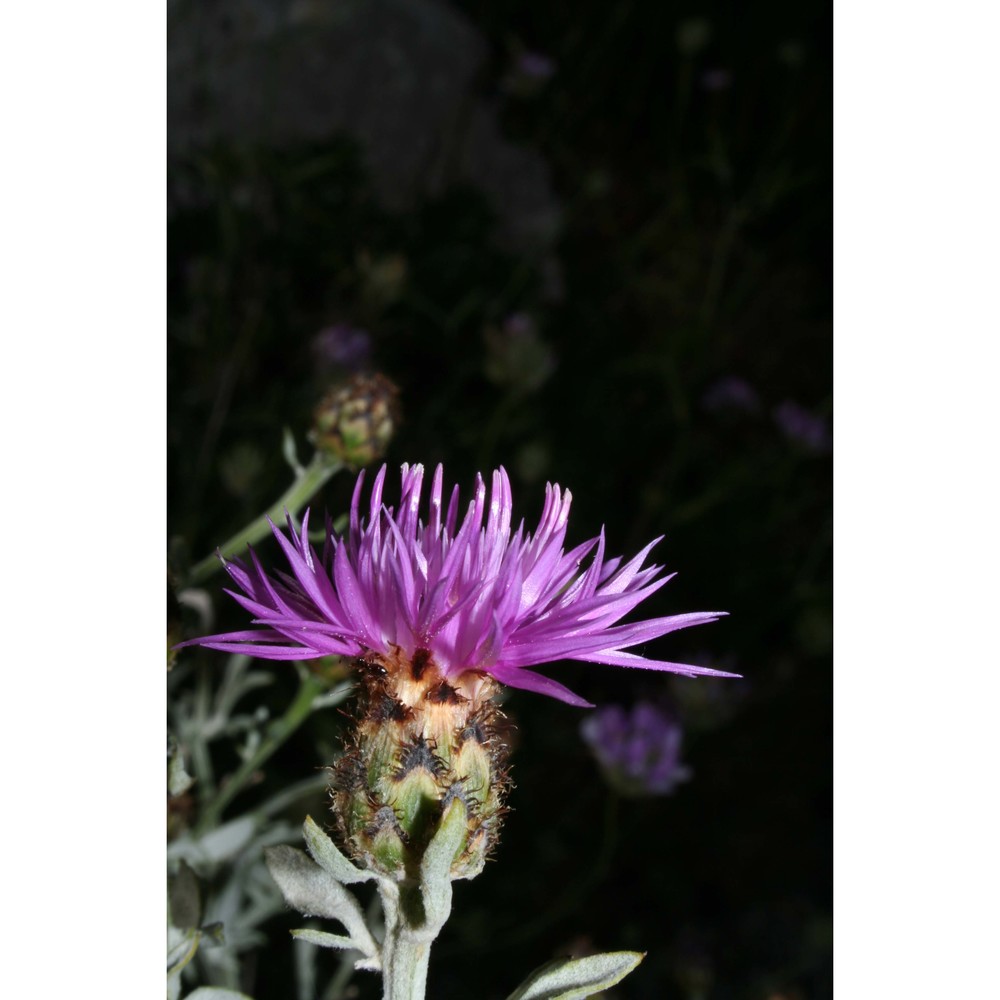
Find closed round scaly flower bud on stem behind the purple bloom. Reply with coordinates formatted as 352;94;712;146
310;374;400;468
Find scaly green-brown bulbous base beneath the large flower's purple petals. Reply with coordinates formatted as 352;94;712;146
331;650;509;882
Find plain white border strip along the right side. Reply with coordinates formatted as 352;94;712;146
834;2;1000;998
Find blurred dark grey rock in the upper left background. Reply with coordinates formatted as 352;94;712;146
168;0;559;252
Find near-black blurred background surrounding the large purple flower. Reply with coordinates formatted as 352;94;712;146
168;0;832;1000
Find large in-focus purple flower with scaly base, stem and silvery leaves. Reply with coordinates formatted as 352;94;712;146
182;465;733;1000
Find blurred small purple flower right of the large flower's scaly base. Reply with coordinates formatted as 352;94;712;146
580;701;691;795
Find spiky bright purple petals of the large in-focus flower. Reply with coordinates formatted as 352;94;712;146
180;465;736;706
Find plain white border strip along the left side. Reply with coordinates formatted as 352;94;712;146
0;2;166;996
